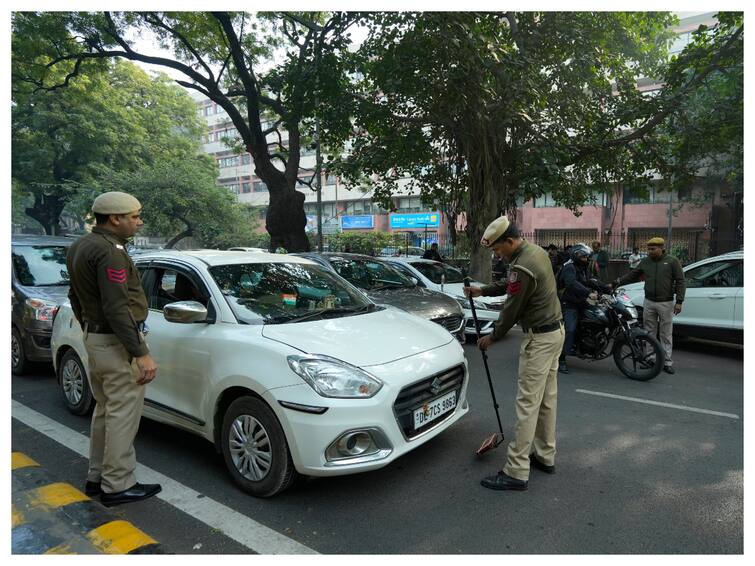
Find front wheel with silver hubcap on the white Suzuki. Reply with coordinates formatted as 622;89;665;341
221;396;297;497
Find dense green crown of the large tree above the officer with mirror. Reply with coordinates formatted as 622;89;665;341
332;12;741;282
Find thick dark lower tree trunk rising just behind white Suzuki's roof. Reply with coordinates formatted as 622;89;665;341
265;187;310;252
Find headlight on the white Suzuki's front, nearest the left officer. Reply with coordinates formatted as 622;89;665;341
287;356;383;399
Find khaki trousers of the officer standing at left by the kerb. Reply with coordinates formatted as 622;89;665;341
84;334;144;493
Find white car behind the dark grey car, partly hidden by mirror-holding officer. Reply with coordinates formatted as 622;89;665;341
383;257;506;338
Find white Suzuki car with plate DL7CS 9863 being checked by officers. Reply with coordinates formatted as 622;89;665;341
52;250;469;497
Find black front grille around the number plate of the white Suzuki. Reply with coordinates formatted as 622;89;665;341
393;366;464;440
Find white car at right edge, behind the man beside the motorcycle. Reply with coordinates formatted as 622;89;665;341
624;251;744;343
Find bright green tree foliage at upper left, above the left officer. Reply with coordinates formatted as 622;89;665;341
12;51;207;233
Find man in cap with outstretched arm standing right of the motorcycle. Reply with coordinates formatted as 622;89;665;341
614;238;685;373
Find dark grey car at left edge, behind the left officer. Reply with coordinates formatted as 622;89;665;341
11;234;75;374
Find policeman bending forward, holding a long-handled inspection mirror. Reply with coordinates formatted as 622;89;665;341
465;216;564;490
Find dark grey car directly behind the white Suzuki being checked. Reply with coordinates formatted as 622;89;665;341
292;252;464;341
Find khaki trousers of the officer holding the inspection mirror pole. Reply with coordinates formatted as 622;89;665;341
503;325;564;480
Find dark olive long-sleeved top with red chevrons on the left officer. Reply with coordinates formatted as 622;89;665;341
66;226;149;357
